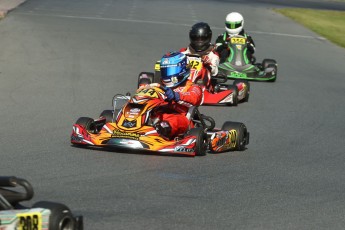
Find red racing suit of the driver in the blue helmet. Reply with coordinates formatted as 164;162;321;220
154;80;202;139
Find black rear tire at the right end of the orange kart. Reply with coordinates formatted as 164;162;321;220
222;121;249;151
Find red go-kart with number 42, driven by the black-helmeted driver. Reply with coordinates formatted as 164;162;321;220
138;54;250;106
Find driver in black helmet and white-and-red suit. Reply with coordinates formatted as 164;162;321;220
180;22;219;86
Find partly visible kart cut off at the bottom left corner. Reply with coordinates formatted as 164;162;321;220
0;176;83;230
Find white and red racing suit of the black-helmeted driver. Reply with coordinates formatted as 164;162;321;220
180;45;219;86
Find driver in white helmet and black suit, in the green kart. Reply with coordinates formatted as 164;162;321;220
216;12;255;64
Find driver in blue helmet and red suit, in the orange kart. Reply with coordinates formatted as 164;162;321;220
155;52;202;139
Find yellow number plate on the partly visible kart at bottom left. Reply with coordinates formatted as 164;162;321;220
17;212;42;230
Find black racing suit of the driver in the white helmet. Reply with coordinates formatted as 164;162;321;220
216;30;255;64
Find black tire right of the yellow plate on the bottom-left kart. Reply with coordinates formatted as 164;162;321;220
33;201;76;230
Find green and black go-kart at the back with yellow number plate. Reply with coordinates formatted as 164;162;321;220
218;35;278;82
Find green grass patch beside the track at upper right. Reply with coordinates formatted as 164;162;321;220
274;8;345;48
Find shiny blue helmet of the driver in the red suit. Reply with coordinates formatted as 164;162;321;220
160;52;189;87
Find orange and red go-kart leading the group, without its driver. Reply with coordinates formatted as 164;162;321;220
71;84;249;156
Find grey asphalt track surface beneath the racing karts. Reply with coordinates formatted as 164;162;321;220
0;0;345;230
